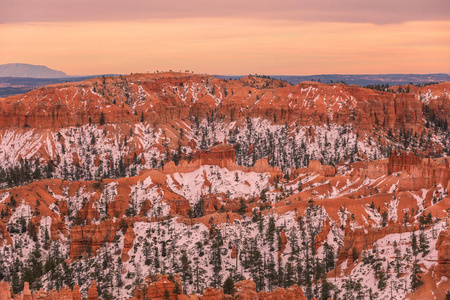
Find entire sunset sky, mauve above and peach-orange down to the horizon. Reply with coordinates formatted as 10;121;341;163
0;0;450;75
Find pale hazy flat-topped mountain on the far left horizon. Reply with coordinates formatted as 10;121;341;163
0;63;67;78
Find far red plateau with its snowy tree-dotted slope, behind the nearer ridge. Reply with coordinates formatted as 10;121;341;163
0;73;450;186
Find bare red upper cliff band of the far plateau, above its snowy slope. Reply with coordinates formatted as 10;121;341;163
0;73;449;132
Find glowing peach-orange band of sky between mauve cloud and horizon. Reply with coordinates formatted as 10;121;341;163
0;18;450;75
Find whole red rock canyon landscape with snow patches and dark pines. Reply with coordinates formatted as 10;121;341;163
0;73;450;299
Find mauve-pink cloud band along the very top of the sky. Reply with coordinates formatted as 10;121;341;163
0;0;450;24
